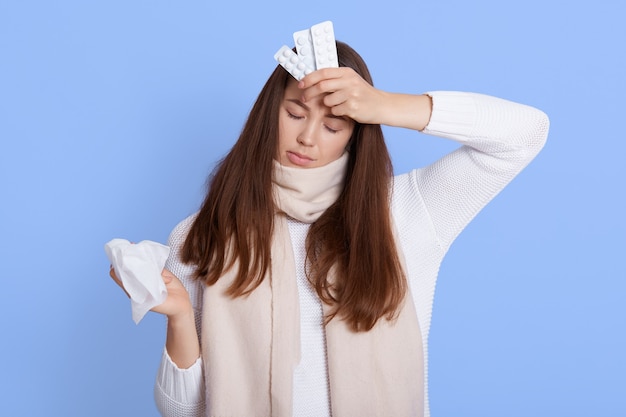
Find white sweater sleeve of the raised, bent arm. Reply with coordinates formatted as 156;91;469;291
412;92;549;250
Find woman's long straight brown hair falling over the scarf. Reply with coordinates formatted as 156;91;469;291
182;42;407;331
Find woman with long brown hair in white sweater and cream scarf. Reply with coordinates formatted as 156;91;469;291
112;42;548;417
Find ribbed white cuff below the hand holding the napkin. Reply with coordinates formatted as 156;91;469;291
156;349;204;404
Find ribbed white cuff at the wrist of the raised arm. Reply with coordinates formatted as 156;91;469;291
423;91;476;137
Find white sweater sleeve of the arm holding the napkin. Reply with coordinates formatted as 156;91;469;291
154;216;205;417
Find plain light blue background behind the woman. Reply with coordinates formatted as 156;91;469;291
0;0;626;417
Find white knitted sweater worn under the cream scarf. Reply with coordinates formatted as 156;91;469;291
154;92;549;417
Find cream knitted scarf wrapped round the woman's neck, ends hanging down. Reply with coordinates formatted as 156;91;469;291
201;153;424;417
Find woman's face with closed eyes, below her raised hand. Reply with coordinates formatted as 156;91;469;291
276;80;354;168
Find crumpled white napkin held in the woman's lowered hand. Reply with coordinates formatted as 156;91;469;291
104;239;170;324
